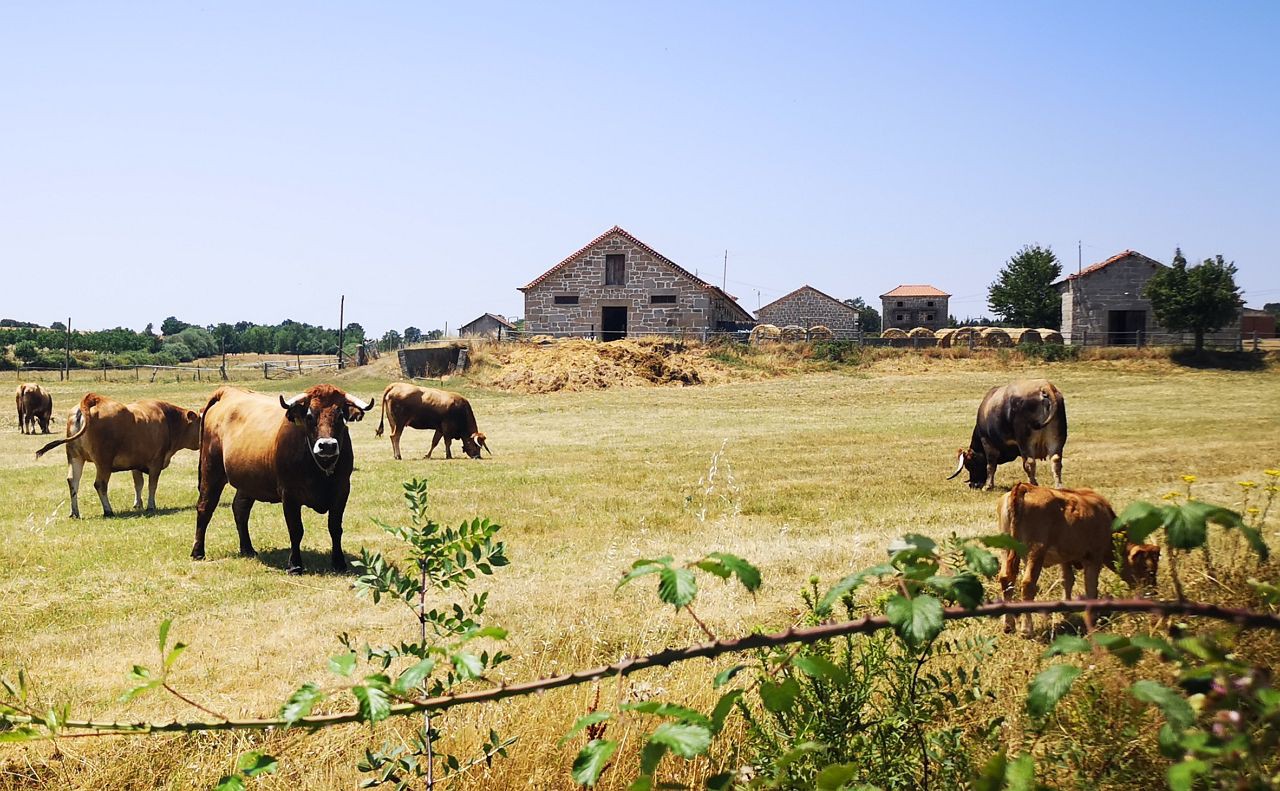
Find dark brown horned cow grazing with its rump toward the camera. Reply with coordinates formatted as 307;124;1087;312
947;379;1066;490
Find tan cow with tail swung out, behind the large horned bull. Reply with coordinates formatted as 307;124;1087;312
36;393;200;518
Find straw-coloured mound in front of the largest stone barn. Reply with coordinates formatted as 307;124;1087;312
471;338;728;393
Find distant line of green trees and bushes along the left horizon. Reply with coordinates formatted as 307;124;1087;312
0;316;365;367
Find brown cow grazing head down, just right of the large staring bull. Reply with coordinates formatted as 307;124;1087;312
374;381;493;458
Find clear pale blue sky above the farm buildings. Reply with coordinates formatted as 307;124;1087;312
0;0;1280;334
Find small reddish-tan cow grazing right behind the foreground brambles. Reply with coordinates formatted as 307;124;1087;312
997;483;1160;635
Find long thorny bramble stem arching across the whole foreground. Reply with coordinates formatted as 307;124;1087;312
10;599;1280;739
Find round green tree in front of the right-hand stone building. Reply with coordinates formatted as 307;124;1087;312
1142;247;1243;352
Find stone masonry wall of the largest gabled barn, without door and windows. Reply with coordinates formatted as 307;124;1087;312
525;234;736;335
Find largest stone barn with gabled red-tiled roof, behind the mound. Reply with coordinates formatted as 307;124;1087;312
520;225;755;340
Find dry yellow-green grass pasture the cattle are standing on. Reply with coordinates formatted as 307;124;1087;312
0;353;1280;790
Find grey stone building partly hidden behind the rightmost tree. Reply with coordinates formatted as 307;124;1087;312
1053;250;1240;346
